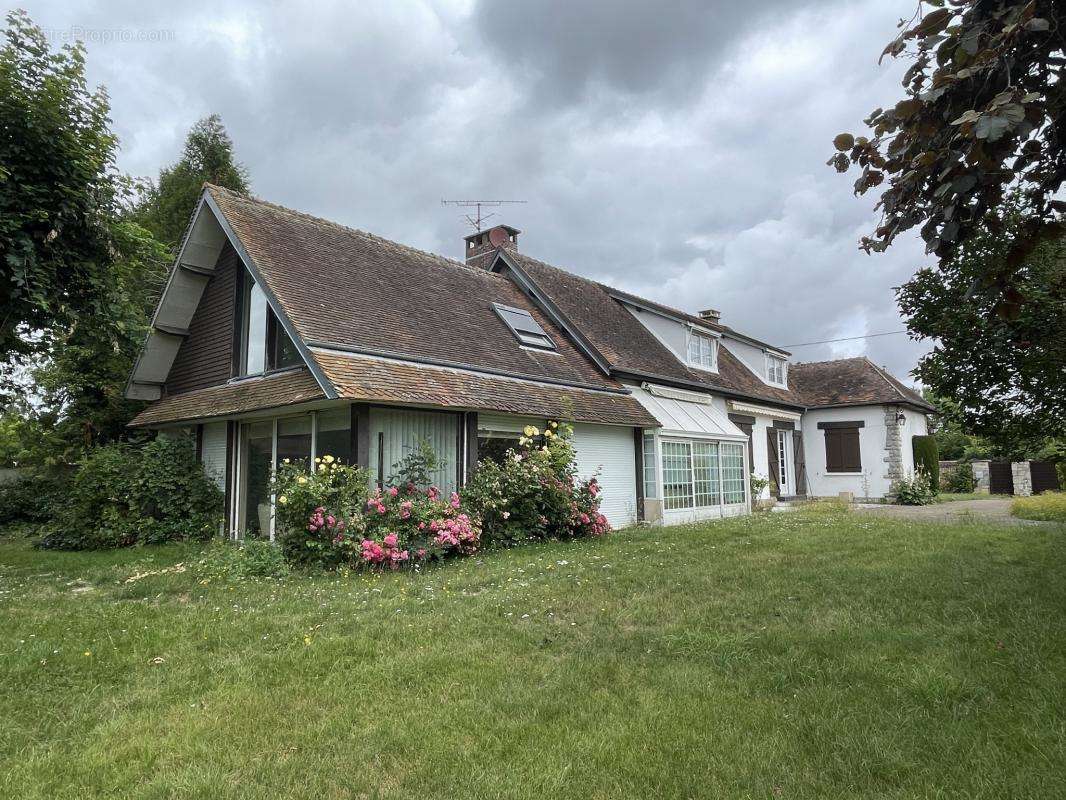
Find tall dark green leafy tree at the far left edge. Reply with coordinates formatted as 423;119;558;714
0;11;122;359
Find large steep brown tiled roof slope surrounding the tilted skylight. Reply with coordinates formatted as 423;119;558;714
208;187;617;387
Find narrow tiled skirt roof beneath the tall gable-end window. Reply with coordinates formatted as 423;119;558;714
130;369;325;428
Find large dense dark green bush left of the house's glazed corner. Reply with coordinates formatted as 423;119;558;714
37;436;222;550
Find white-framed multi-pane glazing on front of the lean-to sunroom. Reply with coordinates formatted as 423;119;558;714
662;439;745;511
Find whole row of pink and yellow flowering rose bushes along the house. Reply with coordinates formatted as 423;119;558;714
273;423;610;569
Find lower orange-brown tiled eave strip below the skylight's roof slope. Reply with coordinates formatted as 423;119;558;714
312;350;659;428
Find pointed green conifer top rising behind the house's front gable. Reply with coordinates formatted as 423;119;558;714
133;114;248;250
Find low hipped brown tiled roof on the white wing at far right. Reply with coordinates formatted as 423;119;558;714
789;357;933;411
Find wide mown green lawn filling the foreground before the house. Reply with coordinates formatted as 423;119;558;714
0;505;1066;800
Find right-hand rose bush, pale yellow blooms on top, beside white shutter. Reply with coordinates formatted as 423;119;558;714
463;422;611;545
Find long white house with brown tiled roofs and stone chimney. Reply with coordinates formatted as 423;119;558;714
127;186;931;537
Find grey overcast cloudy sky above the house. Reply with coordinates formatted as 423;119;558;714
23;0;926;380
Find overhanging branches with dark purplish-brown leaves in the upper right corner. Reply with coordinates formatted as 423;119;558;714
829;0;1066;273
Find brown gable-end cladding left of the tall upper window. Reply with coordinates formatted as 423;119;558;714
166;242;243;395
